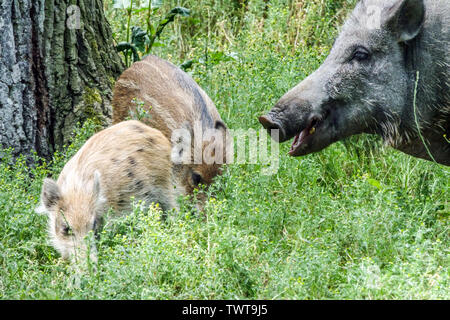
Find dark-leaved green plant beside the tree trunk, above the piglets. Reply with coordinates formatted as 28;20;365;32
113;0;190;67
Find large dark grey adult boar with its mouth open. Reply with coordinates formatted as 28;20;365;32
259;0;450;166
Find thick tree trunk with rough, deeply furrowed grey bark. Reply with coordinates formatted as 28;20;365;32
0;0;123;162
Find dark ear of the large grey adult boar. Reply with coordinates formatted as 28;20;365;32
383;0;425;42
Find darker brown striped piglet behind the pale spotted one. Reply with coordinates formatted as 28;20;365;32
112;55;226;198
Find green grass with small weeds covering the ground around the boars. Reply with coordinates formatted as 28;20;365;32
0;0;450;299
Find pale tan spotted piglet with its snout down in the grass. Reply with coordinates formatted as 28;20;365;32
36;121;176;261
